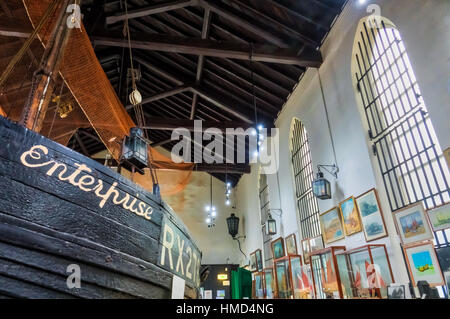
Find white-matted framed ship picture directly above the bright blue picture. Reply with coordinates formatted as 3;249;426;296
394;202;433;245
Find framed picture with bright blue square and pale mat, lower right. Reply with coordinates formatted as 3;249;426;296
403;241;445;287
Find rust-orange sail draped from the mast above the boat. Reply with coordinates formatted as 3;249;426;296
23;0;193;195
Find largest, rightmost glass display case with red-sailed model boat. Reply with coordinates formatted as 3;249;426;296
336;245;394;298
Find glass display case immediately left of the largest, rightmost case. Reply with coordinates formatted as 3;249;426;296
309;246;345;299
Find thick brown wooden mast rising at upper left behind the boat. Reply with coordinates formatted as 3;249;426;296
20;0;72;132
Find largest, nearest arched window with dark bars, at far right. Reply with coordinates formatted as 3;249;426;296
353;17;450;247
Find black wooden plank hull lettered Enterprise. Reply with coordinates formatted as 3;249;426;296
0;116;201;298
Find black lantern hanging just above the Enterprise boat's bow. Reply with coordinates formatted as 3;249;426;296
122;127;148;170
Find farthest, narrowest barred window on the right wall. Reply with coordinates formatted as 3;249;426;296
259;173;273;267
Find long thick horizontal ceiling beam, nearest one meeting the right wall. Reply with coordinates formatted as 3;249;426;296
91;34;322;67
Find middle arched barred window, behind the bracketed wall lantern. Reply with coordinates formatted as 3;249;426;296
291;119;320;239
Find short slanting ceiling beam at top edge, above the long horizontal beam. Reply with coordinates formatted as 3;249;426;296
106;0;198;24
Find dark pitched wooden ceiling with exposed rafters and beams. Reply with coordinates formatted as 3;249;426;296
0;0;347;184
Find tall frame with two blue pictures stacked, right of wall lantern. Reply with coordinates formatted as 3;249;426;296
355;188;388;242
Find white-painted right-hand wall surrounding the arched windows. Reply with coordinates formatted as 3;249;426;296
237;0;450;290
